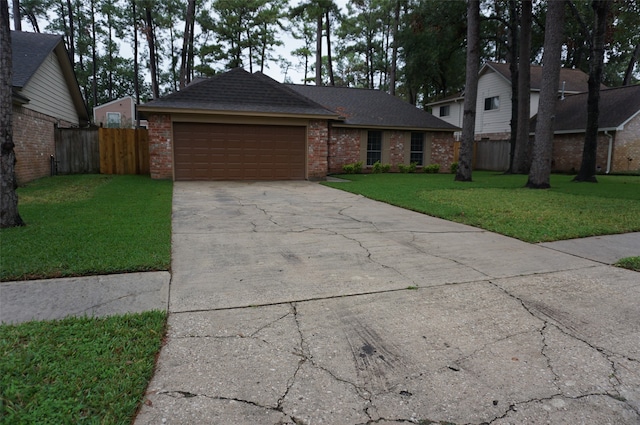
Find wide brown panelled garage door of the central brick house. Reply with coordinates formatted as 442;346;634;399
173;123;306;180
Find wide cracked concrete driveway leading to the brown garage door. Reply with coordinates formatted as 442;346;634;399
136;182;640;425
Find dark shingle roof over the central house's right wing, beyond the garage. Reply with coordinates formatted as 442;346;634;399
289;85;458;131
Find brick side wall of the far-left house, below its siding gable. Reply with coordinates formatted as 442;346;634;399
13;106;71;185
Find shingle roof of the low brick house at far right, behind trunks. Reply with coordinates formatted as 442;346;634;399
531;84;640;132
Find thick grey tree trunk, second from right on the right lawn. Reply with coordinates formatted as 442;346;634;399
526;1;565;189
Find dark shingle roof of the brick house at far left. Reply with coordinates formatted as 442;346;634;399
11;31;62;88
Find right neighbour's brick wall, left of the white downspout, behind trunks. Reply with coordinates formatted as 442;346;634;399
551;133;609;173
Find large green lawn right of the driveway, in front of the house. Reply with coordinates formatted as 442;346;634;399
324;171;640;243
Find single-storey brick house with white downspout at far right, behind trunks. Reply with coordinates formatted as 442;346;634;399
531;85;640;173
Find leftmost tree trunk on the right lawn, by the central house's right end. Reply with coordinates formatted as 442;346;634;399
455;0;480;182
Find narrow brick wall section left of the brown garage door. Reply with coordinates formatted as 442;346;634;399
149;114;173;179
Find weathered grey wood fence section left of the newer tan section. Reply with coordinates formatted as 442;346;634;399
55;128;100;174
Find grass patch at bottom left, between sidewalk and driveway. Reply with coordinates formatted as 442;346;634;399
0;311;166;424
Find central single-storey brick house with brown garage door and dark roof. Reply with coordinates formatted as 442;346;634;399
139;69;458;180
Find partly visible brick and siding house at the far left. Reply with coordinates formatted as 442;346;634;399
11;31;89;184
